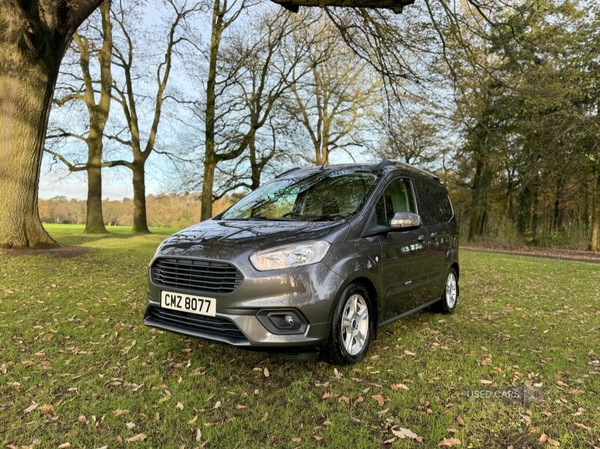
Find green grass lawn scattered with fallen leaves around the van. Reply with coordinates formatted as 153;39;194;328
0;226;600;448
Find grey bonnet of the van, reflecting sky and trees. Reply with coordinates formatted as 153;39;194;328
157;220;348;260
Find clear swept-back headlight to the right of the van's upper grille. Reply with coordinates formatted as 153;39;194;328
250;240;329;271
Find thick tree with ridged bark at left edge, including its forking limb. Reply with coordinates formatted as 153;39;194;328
0;0;100;248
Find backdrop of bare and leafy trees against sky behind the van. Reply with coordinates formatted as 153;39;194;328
40;0;600;250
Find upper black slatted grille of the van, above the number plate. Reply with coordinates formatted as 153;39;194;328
151;259;244;294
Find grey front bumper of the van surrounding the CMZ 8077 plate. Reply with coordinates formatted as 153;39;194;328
144;256;343;349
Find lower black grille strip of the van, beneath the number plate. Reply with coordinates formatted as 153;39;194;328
146;307;247;343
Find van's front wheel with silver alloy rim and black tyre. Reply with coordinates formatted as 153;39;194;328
321;283;373;365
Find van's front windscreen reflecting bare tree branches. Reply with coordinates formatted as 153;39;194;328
221;171;377;221
